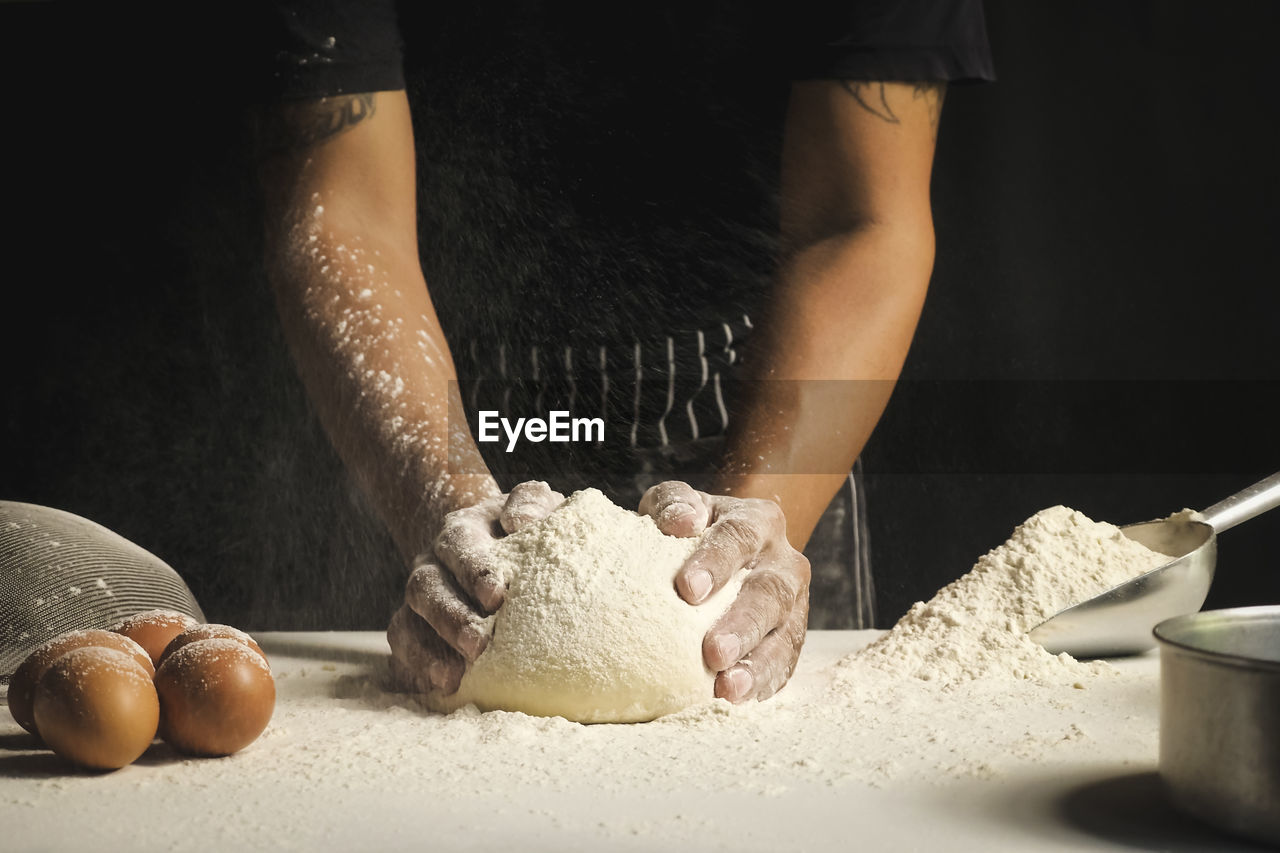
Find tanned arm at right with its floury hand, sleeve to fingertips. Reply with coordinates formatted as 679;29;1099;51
641;82;942;702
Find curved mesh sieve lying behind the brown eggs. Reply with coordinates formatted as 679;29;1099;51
0;501;205;681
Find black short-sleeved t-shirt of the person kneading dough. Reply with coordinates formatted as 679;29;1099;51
254;0;992;467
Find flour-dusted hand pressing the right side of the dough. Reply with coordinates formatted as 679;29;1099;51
640;480;809;702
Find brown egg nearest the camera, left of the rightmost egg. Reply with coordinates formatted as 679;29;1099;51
32;646;160;770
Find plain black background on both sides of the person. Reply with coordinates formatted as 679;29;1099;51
0;0;1280;629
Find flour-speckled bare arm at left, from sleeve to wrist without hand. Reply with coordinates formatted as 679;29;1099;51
259;91;499;561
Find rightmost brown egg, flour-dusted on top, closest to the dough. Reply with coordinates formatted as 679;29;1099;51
156;638;275;756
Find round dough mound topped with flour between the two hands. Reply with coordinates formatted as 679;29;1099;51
425;489;741;722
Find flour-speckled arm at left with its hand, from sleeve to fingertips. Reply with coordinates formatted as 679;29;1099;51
257;91;548;686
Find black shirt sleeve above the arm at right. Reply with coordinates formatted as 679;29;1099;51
791;0;996;82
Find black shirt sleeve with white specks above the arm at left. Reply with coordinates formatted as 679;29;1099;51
260;0;404;100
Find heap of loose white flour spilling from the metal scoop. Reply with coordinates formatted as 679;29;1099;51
842;506;1169;685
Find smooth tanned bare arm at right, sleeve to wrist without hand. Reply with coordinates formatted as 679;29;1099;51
718;81;943;548
